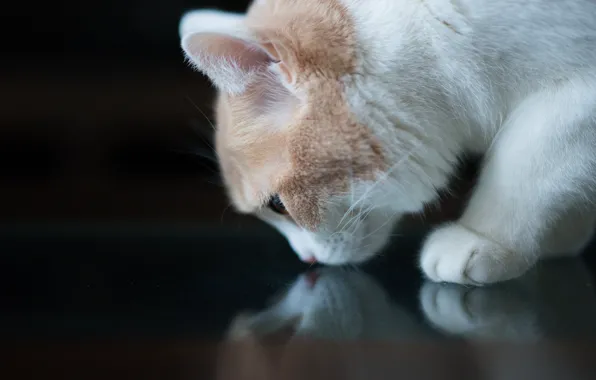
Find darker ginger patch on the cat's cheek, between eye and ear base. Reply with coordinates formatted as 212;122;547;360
281;83;385;229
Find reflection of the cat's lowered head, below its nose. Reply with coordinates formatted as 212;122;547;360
229;268;429;340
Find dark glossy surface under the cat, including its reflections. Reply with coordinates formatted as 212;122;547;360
0;225;596;380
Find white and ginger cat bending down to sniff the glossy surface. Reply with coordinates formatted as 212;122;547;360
179;0;596;285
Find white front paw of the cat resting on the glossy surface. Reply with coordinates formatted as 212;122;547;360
420;223;533;285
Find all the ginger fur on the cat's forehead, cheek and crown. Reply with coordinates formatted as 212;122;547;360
193;0;386;230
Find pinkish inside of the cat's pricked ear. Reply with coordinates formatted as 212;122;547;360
187;33;272;72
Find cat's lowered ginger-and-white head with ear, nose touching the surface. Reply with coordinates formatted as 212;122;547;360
180;0;422;264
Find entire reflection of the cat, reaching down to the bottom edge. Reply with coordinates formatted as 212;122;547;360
218;261;596;380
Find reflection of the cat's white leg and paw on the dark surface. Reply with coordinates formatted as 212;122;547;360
420;260;596;343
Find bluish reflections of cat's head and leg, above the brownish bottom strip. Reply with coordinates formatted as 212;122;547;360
229;260;596;343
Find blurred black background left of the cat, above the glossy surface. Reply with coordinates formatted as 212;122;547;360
0;0;260;224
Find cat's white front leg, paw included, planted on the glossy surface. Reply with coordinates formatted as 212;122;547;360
421;81;596;285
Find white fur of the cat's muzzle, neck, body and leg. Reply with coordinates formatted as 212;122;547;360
181;0;596;284
